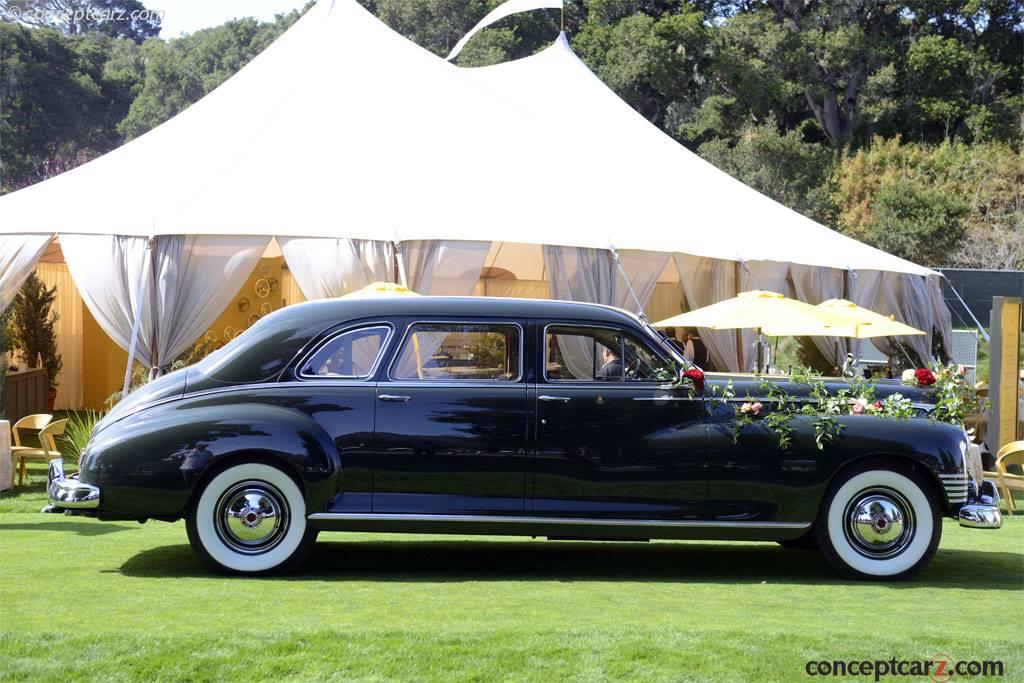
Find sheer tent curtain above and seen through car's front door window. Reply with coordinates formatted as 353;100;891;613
544;245;669;377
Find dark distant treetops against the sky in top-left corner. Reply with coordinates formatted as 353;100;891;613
0;0;161;43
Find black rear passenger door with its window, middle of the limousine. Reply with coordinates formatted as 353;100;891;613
373;319;527;515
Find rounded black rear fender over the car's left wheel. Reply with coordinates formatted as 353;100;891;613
80;401;342;517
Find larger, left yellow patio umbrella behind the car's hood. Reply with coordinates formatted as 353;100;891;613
654;290;828;372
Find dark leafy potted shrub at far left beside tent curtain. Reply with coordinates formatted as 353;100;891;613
10;272;63;412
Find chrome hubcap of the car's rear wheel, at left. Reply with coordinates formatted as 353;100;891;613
216;481;288;555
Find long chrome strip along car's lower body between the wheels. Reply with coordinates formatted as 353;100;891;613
307;512;811;529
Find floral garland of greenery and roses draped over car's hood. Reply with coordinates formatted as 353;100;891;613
672;365;983;450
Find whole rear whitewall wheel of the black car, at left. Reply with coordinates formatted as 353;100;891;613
185;463;316;575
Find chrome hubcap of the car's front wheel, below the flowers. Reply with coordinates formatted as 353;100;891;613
844;488;914;559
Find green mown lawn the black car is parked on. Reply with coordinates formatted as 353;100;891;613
0;467;1024;681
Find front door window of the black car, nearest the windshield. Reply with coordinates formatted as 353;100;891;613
545;326;666;382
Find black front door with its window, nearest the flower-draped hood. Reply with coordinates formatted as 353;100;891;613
532;322;708;519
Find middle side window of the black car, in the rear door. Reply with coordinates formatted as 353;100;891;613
391;323;522;382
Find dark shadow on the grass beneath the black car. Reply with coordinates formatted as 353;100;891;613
121;540;1024;591
